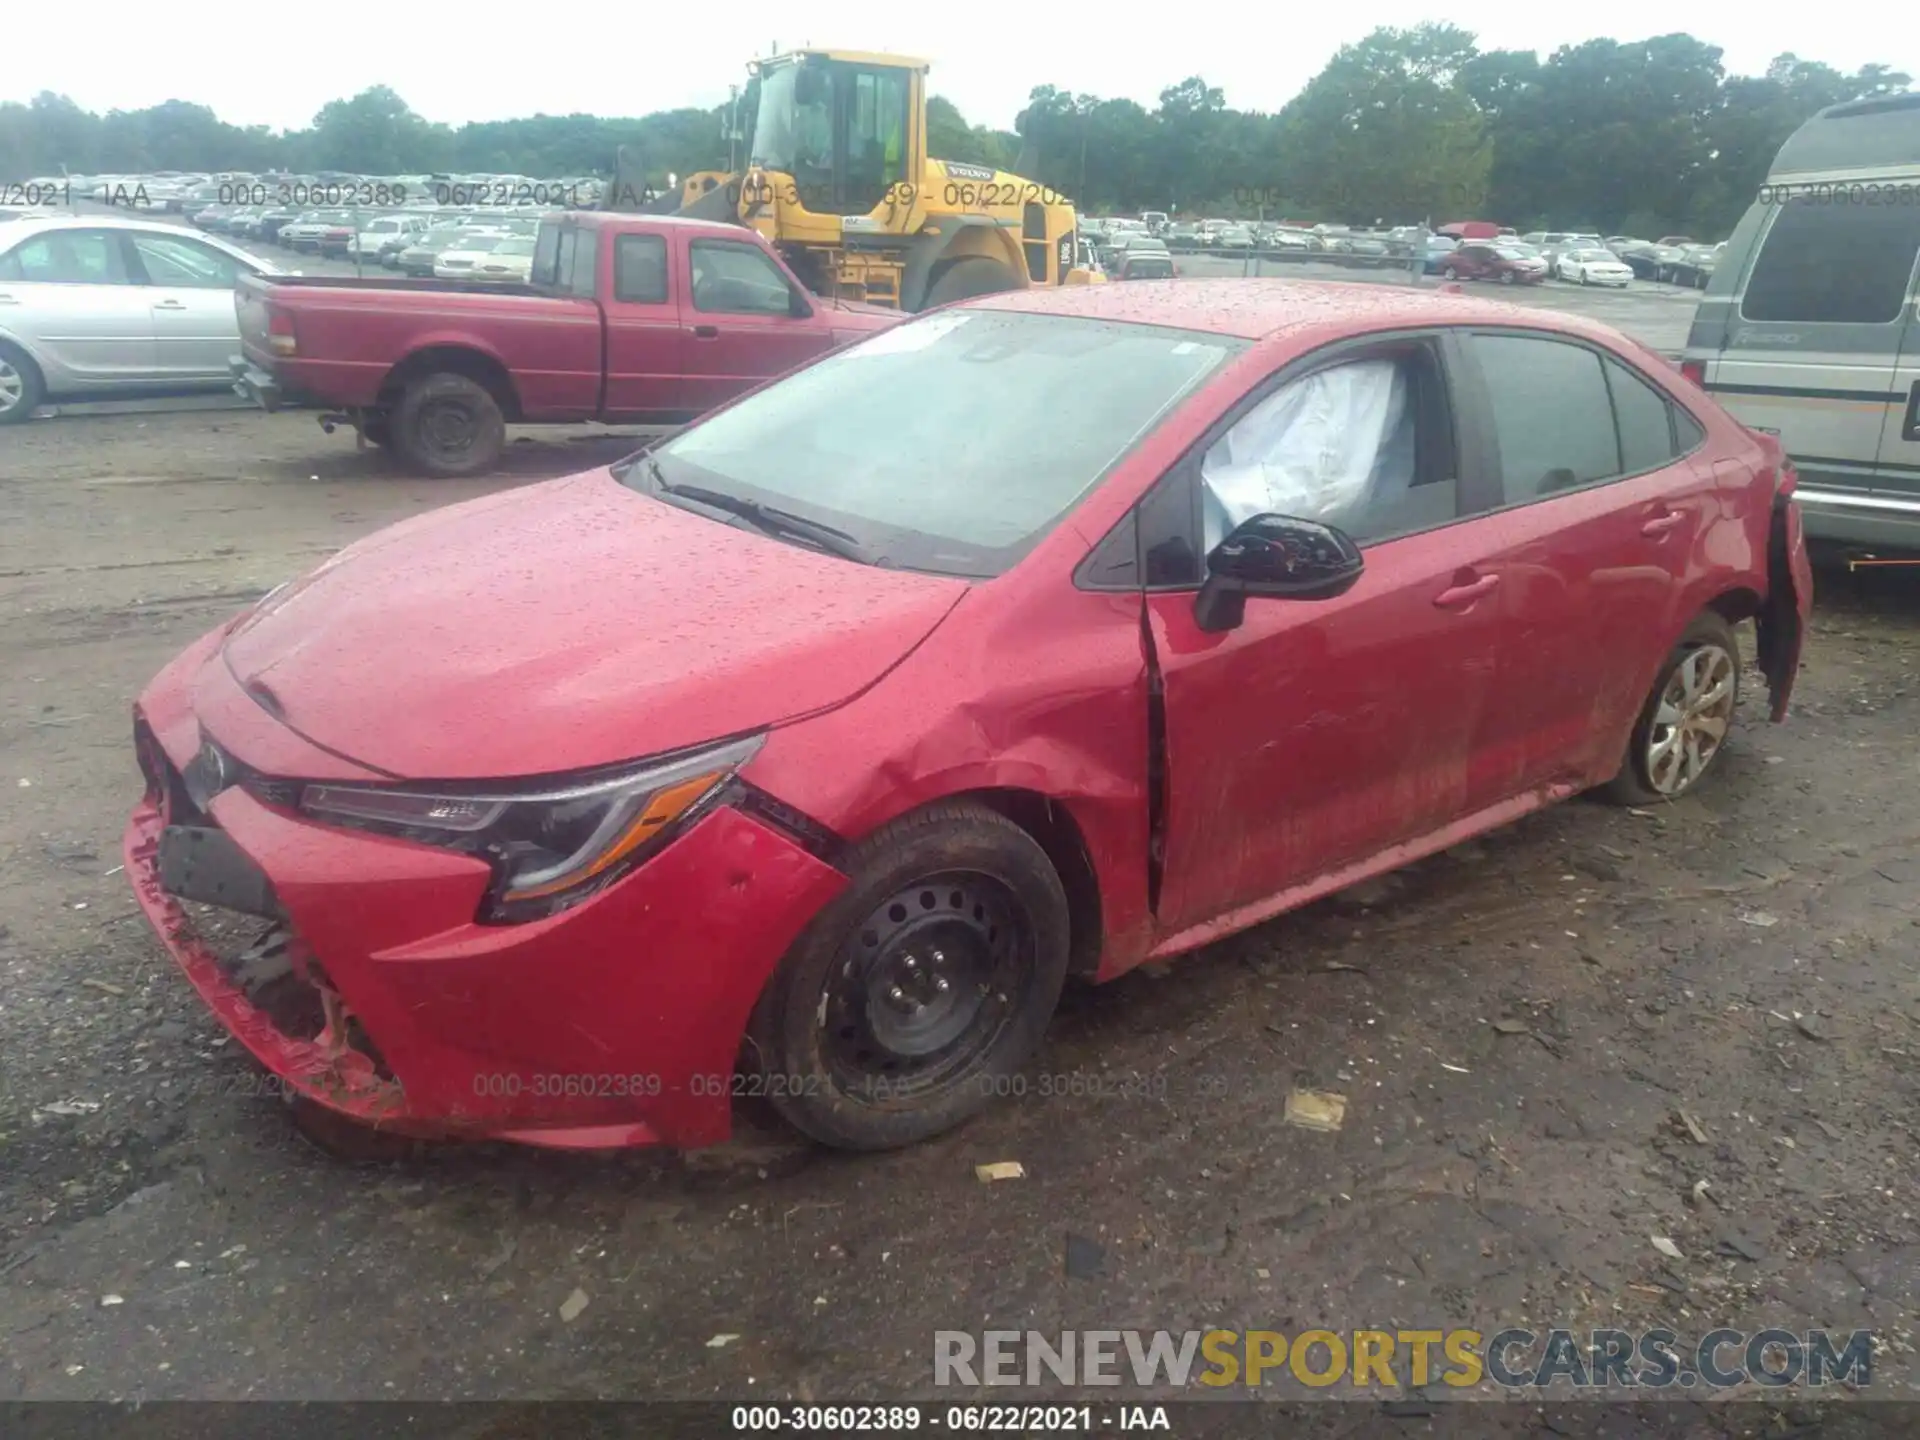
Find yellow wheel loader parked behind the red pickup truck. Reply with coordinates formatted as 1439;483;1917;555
605;50;1104;311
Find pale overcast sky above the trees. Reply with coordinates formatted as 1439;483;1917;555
0;0;1920;129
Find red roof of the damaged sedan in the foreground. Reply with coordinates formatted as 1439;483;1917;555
964;276;1620;346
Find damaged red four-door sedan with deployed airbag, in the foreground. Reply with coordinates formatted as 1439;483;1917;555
125;280;1811;1148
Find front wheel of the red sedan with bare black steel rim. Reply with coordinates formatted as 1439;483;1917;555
747;803;1069;1150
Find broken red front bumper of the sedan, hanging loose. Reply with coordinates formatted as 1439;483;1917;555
123;641;847;1148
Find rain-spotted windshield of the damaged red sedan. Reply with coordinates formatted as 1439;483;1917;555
616;309;1246;578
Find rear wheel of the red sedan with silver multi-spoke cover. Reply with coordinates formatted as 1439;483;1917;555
1603;611;1740;804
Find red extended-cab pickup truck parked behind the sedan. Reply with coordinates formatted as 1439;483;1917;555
232;211;904;476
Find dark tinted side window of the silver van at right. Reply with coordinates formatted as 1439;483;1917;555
1740;196;1920;324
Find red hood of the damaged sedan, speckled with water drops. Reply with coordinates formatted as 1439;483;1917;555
221;470;968;780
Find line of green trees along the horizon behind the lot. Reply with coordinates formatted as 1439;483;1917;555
0;23;1910;236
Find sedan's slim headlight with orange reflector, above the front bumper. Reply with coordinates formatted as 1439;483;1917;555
300;735;766;922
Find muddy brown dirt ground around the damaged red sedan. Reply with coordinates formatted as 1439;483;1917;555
0;374;1920;1432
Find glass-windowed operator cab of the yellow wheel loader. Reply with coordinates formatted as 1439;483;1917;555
749;50;925;215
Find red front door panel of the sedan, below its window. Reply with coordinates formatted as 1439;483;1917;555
1146;520;1500;933
